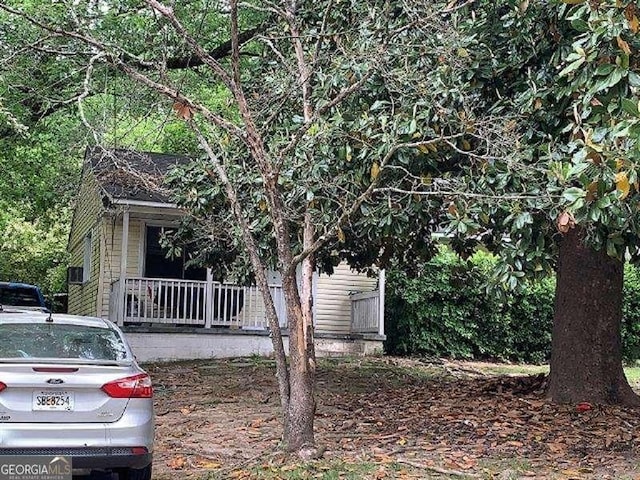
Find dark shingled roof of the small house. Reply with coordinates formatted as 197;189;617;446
85;146;191;203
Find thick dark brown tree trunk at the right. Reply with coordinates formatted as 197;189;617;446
547;228;640;405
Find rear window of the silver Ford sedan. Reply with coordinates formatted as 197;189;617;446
0;323;127;361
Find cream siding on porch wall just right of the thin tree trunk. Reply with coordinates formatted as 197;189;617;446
314;263;377;335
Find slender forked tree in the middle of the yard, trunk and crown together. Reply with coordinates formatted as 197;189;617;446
0;0;511;456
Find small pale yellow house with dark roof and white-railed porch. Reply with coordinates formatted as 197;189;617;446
68;147;384;360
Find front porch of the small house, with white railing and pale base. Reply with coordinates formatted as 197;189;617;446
103;205;385;361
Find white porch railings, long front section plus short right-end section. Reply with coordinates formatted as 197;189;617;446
109;275;384;337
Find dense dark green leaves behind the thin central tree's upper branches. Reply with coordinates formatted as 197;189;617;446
154;2;496;276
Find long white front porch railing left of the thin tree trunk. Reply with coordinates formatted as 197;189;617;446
109;277;287;329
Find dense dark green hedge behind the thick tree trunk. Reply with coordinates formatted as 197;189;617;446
385;250;640;363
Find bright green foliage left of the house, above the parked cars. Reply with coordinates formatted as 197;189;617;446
0;114;84;294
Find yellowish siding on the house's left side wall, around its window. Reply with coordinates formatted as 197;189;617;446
67;170;103;315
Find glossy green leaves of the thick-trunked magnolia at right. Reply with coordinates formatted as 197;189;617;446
430;0;640;282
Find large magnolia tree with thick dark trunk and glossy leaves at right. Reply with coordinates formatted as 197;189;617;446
427;0;640;405
